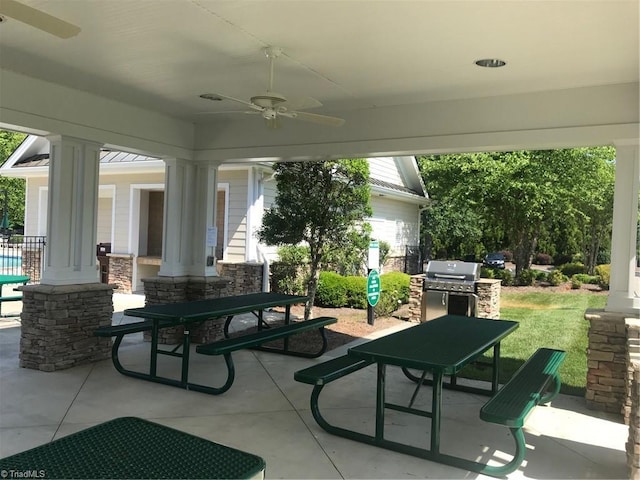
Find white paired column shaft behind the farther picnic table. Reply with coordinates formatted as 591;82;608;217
158;159;218;277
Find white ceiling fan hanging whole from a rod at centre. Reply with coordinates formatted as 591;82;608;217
200;47;345;128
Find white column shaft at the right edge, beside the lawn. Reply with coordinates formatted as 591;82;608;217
605;139;640;316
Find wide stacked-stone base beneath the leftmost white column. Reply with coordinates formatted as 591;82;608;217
19;283;113;372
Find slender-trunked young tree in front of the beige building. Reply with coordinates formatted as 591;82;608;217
257;158;371;319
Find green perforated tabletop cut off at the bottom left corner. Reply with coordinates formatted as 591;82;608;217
0;417;265;480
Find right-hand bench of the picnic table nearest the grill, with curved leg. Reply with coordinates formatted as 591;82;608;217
480;348;566;476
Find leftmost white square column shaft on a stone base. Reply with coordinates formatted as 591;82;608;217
40;135;101;285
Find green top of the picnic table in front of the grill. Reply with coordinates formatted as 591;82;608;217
349;315;519;375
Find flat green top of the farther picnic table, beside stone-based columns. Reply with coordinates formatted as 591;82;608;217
124;292;307;321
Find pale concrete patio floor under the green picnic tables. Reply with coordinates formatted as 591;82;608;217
0;294;628;479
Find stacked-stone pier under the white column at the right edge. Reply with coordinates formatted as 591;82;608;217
584;310;629;413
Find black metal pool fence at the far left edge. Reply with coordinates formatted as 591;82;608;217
0;234;47;283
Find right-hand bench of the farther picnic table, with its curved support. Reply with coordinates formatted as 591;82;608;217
196;317;338;394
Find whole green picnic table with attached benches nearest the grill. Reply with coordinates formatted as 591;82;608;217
294;316;566;477
